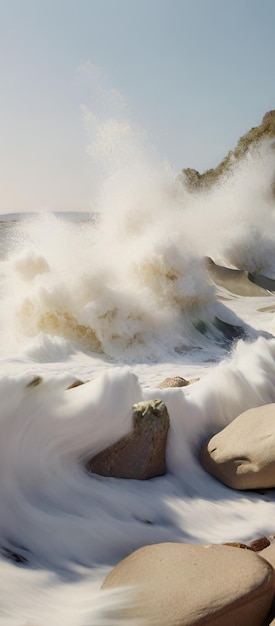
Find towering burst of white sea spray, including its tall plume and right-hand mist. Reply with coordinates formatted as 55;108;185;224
1;86;275;362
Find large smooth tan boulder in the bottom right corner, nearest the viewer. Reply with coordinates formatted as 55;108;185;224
102;543;275;626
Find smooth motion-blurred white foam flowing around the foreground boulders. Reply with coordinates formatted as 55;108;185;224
0;338;275;624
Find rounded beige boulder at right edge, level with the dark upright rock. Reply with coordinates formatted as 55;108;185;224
200;403;275;489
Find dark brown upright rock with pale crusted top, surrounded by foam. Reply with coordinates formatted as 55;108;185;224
86;400;170;480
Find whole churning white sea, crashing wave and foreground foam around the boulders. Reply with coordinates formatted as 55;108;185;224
0;134;275;626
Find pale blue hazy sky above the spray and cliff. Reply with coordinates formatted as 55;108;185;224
0;0;275;214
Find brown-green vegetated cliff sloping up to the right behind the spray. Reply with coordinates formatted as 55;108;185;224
180;110;275;189
